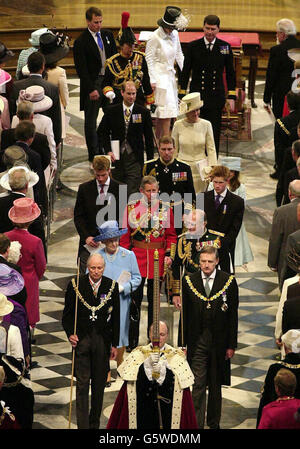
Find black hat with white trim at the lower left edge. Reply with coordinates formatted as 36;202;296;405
0;354;32;388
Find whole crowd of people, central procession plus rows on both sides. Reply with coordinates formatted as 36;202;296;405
0;6;300;429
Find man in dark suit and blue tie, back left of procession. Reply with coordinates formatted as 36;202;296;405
73;7;117;162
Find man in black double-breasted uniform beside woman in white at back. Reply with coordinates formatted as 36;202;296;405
179;15;236;154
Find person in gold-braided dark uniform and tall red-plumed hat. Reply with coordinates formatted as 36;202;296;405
102;13;154;106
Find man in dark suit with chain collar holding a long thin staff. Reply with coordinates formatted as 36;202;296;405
62;254;120;429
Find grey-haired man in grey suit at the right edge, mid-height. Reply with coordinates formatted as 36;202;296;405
268;179;300;290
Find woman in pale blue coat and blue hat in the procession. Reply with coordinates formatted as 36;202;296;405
94;220;142;386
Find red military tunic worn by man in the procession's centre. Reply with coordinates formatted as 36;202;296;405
120;200;177;279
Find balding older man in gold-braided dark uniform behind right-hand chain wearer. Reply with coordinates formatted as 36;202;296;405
171;209;221;308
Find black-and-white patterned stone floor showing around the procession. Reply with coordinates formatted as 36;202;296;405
26;78;279;429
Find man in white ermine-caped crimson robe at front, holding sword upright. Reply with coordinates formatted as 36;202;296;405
107;321;197;429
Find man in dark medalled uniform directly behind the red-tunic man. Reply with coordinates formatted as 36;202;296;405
143;136;196;234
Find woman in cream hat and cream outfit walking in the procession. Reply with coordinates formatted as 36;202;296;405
172;92;217;194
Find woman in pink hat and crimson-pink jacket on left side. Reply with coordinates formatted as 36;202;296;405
6;197;46;328
